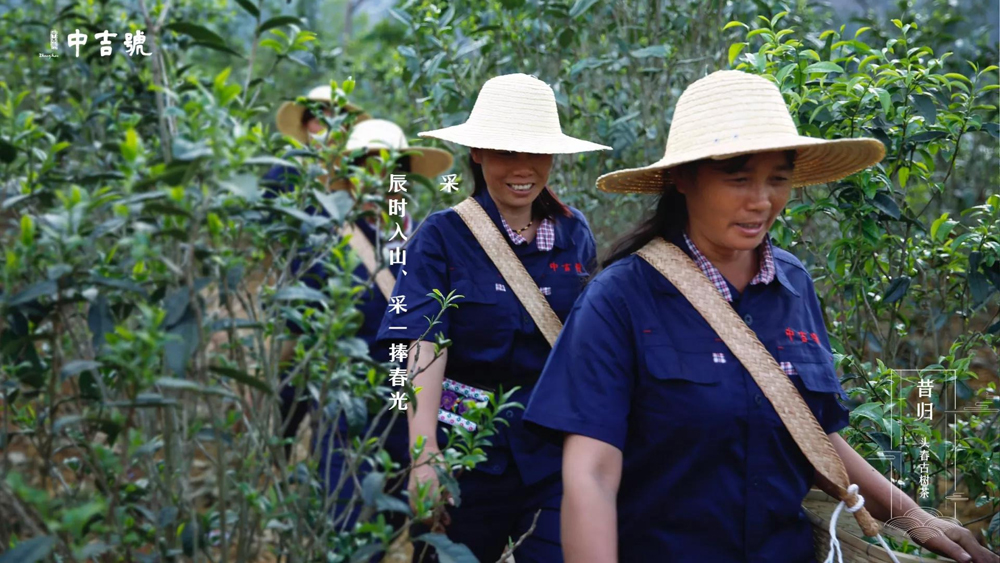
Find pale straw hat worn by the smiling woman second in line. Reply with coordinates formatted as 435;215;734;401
419;74;611;154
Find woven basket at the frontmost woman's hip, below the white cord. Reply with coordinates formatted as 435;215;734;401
802;489;955;563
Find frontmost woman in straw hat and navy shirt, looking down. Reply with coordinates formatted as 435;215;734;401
524;71;987;563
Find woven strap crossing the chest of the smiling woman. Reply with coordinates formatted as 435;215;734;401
454;197;562;346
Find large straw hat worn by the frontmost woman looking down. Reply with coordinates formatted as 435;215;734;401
597;70;885;193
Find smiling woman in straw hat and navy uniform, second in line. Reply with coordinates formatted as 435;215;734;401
379;74;608;563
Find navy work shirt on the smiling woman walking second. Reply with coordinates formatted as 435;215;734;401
378;190;597;484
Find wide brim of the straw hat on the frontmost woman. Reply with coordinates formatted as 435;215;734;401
597;135;885;194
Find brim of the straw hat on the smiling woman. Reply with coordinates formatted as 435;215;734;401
417;122;611;154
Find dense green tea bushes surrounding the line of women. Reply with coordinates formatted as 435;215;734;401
0;0;1000;563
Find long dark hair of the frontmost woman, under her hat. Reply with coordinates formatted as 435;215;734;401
601;150;796;269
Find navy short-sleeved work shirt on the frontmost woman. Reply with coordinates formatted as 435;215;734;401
524;231;848;563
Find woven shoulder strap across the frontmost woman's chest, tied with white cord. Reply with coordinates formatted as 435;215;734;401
636;237;879;537
